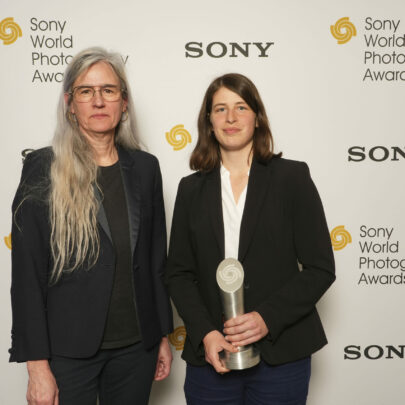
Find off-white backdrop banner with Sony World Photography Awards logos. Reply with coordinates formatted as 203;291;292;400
0;0;405;405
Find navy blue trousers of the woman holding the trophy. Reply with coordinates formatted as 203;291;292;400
184;357;311;405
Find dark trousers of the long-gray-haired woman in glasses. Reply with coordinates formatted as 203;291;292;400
50;343;159;405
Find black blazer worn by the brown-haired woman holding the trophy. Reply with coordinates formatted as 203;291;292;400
166;158;335;365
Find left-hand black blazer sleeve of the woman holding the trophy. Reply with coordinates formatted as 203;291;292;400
166;178;216;352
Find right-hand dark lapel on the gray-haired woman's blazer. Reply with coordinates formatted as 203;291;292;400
117;146;141;254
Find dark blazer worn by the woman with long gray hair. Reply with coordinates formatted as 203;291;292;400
10;147;172;362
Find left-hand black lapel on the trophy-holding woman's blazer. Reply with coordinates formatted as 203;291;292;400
206;169;225;258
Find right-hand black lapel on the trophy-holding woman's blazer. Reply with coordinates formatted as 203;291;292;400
238;160;271;262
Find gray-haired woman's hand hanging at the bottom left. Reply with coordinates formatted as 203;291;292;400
27;360;59;405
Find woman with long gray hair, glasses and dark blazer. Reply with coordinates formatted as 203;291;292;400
10;48;172;405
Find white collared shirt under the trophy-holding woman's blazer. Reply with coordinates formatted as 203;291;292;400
221;165;249;259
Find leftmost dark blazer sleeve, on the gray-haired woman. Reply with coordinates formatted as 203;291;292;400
9;152;50;362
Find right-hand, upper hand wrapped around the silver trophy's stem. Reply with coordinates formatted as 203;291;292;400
224;311;269;346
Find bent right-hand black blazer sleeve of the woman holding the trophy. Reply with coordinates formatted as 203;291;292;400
257;163;335;342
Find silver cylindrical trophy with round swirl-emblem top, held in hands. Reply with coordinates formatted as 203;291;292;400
217;258;260;370
